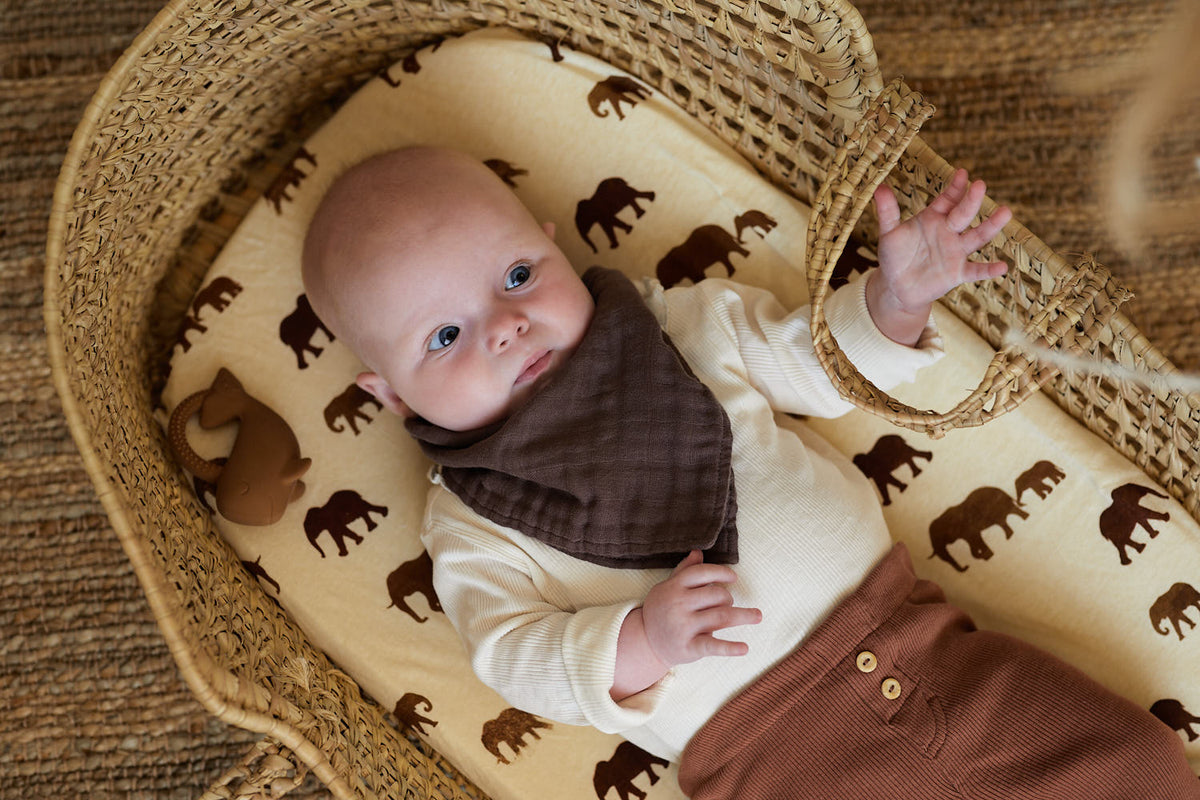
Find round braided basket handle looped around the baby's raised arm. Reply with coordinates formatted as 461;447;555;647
805;79;1106;438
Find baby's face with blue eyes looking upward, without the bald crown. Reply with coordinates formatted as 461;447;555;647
359;170;594;431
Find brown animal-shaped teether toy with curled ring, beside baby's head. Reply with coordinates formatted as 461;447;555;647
167;367;312;525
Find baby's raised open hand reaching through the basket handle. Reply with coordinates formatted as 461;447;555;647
868;169;1013;344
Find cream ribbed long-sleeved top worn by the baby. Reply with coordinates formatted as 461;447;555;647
422;272;942;759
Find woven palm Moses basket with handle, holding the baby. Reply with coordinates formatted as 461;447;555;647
46;0;1200;798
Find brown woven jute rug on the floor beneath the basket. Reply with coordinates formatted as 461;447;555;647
0;0;1200;799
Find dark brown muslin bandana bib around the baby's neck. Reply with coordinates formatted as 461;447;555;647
407;266;738;569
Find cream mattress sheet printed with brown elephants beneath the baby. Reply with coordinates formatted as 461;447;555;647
162;28;1200;800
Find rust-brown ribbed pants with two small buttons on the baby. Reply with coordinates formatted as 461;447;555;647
679;545;1200;800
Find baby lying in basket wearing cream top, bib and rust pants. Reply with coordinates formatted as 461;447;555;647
304;148;1200;799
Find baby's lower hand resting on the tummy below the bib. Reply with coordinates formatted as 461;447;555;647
642;551;762;667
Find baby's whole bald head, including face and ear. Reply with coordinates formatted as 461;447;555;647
304;148;594;431
